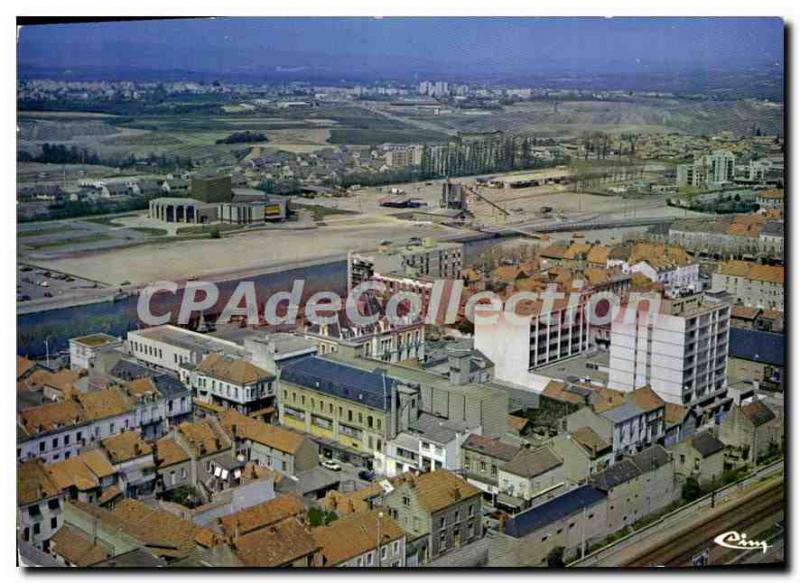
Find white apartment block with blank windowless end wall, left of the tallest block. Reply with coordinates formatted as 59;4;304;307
475;296;590;387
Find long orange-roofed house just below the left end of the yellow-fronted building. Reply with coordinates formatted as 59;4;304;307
219;410;319;476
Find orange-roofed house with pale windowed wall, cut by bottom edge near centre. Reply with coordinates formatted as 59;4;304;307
311;509;406;567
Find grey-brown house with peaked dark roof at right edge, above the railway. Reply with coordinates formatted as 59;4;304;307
719;400;783;464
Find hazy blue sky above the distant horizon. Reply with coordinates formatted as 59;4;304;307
18;18;783;77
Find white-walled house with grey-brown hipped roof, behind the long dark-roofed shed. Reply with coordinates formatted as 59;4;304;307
497;445;565;511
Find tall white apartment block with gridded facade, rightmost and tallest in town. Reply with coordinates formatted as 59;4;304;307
608;294;731;407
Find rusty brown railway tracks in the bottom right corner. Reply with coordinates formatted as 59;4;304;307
619;480;784;567
